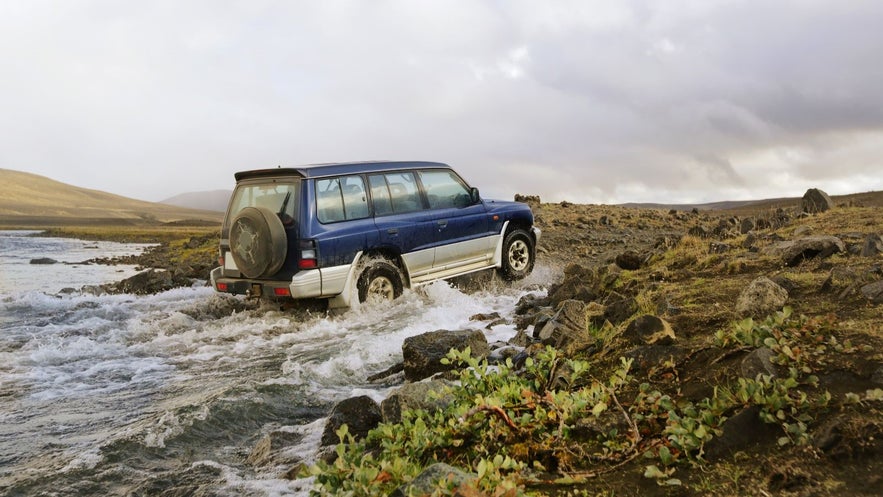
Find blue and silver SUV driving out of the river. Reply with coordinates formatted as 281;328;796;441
211;162;540;307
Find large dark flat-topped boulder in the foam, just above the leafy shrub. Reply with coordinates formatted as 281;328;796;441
402;330;490;381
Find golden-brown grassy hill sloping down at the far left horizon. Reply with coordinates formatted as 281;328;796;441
0;169;223;226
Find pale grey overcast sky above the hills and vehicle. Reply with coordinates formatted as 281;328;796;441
0;0;883;203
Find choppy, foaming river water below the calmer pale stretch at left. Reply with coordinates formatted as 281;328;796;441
0;233;548;496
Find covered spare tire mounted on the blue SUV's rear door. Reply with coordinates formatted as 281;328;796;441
230;207;288;278
